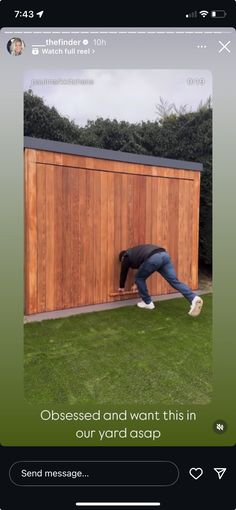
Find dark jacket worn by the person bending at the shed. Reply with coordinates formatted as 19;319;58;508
120;244;165;289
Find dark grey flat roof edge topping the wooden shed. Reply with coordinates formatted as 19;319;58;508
24;136;203;172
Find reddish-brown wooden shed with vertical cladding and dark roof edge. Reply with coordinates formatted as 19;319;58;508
24;137;202;314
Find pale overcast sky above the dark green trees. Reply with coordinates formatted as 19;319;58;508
24;69;212;125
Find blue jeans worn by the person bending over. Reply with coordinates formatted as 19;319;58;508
135;251;196;304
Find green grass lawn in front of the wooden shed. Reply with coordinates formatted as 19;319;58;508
25;295;212;404
